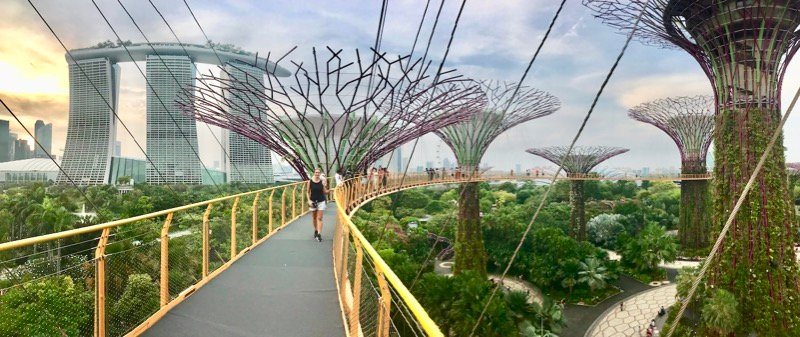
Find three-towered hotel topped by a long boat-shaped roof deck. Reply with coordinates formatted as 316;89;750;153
56;43;289;185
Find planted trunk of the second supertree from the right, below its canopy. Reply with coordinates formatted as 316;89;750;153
678;161;711;249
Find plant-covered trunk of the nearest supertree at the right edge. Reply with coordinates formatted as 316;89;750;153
711;109;800;336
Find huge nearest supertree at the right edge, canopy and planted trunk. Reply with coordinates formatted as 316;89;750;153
584;0;800;336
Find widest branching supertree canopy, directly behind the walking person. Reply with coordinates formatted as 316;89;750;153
178;48;485;178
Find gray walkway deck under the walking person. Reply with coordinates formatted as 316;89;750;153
143;205;344;337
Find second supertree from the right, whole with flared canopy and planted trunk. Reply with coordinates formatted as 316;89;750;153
628;96;714;249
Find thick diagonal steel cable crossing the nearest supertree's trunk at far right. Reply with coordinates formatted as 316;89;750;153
666;55;800;337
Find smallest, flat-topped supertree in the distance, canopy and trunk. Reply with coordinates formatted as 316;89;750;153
525;146;628;241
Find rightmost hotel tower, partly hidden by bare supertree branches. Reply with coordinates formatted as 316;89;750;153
222;61;275;183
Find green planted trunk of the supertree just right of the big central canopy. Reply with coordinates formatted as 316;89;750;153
453;182;486;275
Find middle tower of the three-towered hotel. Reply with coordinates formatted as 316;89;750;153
146;55;201;184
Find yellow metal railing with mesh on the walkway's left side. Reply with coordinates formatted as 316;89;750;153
0;182;308;337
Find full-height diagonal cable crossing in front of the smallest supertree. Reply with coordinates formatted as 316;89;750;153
462;0;651;337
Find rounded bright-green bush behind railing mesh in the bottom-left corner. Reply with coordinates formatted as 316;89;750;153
0;277;93;337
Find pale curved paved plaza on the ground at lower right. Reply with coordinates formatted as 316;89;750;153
586;284;677;337
